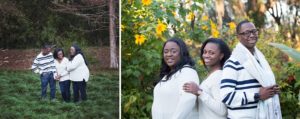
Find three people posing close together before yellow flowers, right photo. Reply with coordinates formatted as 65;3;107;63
152;20;282;119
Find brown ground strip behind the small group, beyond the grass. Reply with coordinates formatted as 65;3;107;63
0;47;117;70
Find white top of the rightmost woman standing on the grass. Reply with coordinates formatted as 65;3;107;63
67;54;90;82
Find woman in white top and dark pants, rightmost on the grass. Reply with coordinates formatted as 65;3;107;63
67;45;90;102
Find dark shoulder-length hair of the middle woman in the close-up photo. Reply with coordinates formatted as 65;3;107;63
200;38;231;68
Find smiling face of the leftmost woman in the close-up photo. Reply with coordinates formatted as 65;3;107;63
163;41;180;69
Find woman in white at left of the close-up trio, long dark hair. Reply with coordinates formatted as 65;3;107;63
152;38;199;119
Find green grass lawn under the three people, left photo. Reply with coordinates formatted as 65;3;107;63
0;71;119;119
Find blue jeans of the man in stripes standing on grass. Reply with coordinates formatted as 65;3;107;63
41;72;56;99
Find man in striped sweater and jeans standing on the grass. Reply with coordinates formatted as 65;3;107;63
31;44;56;101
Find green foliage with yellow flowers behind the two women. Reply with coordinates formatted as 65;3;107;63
121;0;235;118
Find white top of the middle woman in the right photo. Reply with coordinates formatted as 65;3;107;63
199;70;227;119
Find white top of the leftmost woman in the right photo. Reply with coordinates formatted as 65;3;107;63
152;67;199;119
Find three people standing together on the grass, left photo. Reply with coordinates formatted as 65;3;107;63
31;45;89;102
